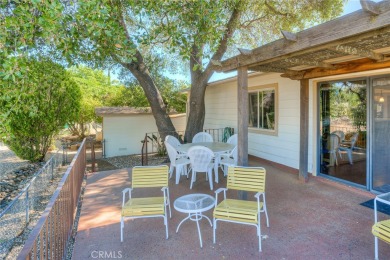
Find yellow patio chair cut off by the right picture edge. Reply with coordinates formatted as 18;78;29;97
372;192;390;259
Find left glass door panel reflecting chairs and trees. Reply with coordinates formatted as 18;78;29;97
318;79;368;186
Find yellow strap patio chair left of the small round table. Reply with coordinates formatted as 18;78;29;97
121;165;172;242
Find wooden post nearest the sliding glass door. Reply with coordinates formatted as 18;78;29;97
299;79;309;182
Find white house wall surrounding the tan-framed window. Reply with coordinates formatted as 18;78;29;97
204;73;300;169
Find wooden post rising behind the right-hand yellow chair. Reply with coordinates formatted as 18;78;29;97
237;67;249;200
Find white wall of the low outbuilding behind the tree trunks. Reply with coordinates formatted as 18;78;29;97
103;114;186;157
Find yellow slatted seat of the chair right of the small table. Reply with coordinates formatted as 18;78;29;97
214;199;263;224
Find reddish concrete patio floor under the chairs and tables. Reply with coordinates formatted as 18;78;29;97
73;161;390;260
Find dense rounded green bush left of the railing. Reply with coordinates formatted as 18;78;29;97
0;59;81;161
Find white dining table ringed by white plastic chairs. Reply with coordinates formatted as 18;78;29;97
177;142;235;183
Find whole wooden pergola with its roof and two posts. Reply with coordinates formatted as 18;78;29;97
214;0;390;181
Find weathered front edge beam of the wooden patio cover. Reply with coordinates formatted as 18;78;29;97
218;1;390;72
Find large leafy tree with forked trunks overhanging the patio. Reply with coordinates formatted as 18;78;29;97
0;0;342;142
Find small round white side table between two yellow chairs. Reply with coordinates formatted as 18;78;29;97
173;193;215;247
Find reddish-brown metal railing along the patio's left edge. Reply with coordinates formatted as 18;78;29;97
18;139;86;259
